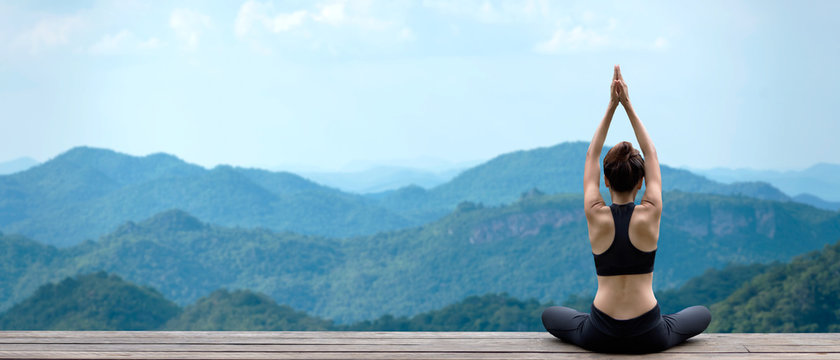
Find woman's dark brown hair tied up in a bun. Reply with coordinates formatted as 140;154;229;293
604;141;645;192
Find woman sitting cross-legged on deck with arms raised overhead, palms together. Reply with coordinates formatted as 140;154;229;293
542;65;711;353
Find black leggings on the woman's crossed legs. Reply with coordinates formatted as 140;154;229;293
542;304;712;354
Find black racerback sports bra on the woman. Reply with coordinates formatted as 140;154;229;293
592;202;656;276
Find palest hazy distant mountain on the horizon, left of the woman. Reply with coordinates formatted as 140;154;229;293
300;166;463;194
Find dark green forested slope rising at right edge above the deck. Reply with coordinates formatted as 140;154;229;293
710;243;840;332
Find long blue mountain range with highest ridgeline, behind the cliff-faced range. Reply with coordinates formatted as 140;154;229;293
0;142;800;246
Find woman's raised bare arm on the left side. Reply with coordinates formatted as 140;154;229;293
583;66;620;212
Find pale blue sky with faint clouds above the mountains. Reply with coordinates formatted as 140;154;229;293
0;0;840;170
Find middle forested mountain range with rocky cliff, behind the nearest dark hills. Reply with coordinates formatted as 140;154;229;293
0;192;840;324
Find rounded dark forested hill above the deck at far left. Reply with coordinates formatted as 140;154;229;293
0;272;180;330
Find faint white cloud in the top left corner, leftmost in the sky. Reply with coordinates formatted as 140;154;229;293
15;16;85;54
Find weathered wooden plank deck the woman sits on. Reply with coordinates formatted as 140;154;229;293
0;331;840;359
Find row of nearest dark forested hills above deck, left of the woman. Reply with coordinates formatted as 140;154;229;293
0;272;551;331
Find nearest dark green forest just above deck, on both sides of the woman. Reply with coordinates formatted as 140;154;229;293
0;243;840;332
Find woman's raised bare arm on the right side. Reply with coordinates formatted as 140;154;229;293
613;65;662;211
